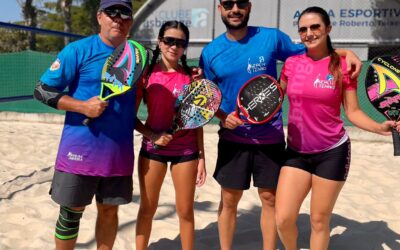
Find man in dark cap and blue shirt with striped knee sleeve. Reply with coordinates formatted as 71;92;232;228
34;0;136;249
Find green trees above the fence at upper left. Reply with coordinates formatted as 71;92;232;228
0;0;146;53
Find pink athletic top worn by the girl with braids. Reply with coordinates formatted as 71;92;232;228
142;65;198;156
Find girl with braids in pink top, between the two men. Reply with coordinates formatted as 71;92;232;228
136;21;206;250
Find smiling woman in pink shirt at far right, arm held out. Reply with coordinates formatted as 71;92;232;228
275;7;400;250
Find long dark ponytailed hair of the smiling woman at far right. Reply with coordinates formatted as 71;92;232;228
297;6;342;88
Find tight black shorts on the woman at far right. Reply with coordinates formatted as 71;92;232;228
285;140;351;181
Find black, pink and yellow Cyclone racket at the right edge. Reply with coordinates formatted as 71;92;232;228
365;55;400;156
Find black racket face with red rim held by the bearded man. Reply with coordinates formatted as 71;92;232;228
236;74;283;124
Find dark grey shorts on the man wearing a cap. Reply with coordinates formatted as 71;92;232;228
50;170;133;207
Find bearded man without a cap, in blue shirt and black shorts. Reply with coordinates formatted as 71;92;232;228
200;0;361;250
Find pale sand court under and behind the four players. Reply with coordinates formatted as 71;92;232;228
0;112;400;250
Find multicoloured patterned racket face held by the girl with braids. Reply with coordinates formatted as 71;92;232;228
173;79;222;132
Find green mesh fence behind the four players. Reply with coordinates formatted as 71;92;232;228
0;51;383;125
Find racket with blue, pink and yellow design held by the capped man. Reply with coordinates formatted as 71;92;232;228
83;40;148;126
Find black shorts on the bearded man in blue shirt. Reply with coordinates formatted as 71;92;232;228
213;140;285;190
